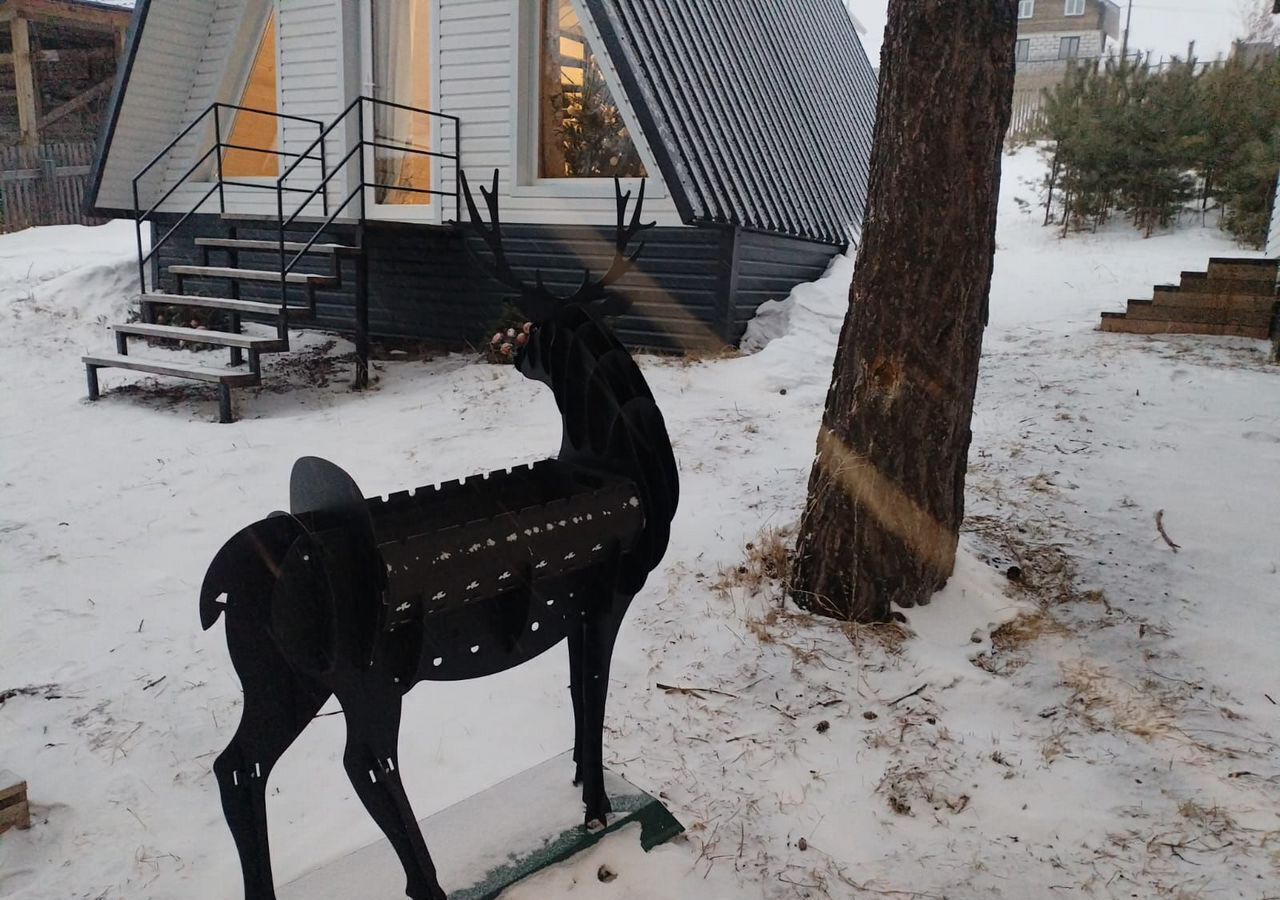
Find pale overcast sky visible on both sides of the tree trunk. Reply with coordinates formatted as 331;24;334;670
849;0;1244;67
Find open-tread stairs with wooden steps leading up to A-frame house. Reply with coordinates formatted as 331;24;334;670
82;237;361;422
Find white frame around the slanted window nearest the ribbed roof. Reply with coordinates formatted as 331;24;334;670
512;0;668;200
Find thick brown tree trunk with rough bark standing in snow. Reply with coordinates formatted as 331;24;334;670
791;0;1018;622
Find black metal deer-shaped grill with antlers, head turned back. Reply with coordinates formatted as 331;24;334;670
200;174;678;900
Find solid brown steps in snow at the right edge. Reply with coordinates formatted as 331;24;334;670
1102;257;1280;339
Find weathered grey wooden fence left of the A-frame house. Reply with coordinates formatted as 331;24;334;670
0;141;104;234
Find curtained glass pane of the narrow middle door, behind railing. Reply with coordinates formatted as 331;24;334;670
372;0;431;205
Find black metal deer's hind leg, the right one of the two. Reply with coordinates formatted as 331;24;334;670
338;691;447;900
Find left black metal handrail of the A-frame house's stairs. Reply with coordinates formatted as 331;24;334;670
132;101;329;293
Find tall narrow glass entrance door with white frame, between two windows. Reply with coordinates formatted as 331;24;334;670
362;0;440;221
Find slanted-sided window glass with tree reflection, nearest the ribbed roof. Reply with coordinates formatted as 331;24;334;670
538;0;645;178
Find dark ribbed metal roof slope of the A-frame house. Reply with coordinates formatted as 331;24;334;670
586;0;877;243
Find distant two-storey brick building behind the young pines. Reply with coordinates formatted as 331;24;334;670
1016;0;1123;88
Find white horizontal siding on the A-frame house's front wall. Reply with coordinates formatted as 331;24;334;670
107;0;680;225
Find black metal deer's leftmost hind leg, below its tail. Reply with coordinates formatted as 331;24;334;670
214;612;329;900
